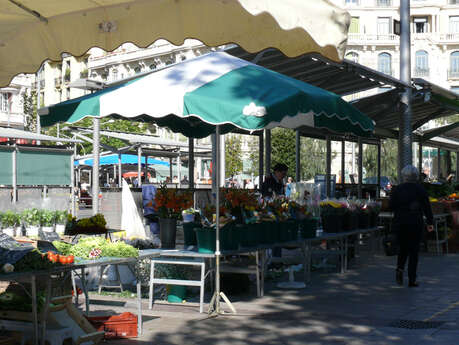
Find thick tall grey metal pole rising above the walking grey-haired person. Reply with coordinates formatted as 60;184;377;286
398;0;412;180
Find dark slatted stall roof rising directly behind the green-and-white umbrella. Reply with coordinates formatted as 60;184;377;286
225;46;409;96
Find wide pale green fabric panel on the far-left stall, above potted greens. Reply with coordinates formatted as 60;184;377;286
17;151;71;186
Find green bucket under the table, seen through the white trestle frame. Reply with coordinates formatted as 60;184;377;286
155;264;191;303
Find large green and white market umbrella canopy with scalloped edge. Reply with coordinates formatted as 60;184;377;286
39;52;374;138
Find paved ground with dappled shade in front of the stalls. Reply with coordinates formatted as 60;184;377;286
92;250;459;345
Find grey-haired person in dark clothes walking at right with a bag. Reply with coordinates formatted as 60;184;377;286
390;165;433;287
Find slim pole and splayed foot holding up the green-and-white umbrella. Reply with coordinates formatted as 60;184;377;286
209;125;236;315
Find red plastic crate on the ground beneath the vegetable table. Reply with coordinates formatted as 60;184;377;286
87;312;137;339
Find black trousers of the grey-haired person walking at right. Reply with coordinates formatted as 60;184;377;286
397;224;423;283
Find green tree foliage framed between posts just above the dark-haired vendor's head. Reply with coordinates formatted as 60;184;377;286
271;128;296;176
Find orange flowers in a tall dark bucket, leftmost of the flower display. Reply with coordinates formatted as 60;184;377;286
154;183;193;249
